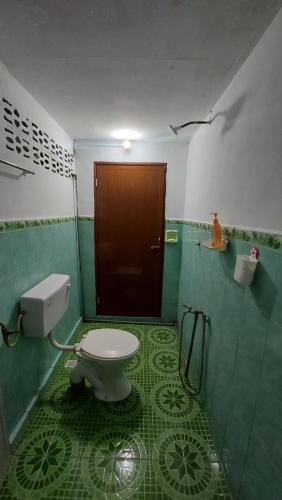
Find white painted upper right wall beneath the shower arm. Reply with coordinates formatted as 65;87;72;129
184;10;282;232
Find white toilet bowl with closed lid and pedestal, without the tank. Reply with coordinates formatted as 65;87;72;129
70;328;139;401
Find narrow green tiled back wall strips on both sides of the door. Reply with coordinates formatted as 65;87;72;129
79;217;182;321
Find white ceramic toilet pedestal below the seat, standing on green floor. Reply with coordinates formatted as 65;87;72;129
70;357;131;402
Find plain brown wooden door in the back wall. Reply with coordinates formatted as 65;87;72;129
94;163;166;316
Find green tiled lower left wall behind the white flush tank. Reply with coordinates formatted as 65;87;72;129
0;220;80;435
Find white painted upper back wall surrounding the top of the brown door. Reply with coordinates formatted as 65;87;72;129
75;141;188;219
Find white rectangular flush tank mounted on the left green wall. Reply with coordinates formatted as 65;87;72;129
21;274;70;338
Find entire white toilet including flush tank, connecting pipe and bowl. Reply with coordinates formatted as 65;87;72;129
21;274;139;401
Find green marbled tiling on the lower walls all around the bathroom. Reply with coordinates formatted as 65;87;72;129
0;214;282;500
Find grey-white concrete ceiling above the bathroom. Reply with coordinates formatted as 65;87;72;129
0;0;282;140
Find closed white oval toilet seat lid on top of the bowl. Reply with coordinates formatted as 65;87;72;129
79;328;139;360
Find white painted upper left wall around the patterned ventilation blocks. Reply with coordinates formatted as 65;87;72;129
0;63;73;220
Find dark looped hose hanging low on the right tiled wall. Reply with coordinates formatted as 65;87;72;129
178;307;209;396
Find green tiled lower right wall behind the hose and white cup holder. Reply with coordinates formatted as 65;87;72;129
178;224;282;500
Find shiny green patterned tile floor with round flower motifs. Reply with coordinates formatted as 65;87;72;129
0;323;230;500
